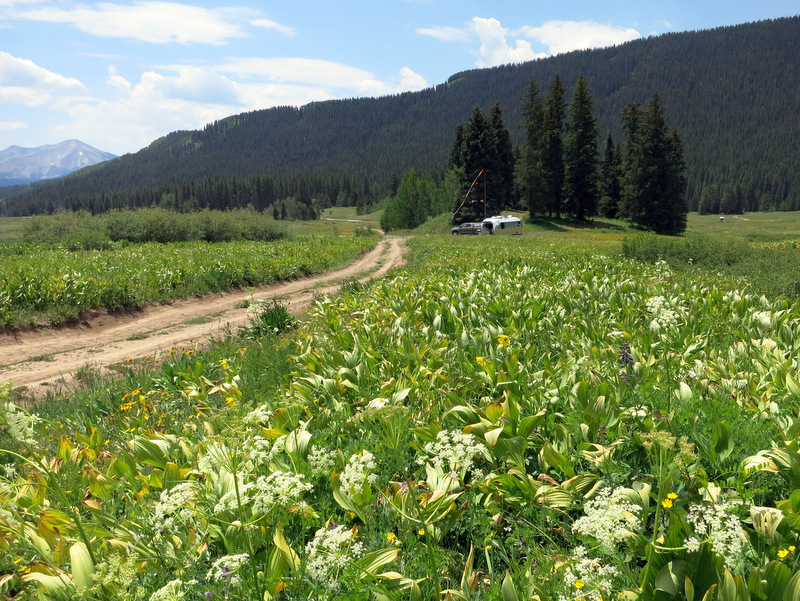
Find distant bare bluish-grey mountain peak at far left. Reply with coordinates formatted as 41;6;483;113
0;140;116;186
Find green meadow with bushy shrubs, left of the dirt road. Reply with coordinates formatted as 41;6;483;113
0;210;375;328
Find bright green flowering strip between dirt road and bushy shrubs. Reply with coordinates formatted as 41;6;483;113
0;230;375;328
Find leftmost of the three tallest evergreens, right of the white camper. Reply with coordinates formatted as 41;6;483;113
517;80;545;219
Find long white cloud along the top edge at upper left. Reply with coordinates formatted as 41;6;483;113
17;0;246;45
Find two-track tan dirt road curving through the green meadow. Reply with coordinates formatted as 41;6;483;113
0;238;406;396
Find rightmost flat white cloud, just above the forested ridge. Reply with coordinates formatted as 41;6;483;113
519;21;642;54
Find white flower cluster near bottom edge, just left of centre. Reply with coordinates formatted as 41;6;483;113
306;524;364;590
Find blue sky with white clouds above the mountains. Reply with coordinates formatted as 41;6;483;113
0;0;800;154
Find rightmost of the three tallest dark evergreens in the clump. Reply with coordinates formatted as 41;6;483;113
564;75;600;221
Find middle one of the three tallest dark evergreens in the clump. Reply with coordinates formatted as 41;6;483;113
542;74;567;217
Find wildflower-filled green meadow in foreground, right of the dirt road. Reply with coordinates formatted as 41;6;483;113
0;214;800;601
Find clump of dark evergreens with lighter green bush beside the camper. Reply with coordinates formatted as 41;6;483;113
382;75;688;234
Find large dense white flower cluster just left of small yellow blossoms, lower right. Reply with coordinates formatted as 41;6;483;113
572;488;642;552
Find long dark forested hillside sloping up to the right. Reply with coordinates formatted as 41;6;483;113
0;17;800;215
